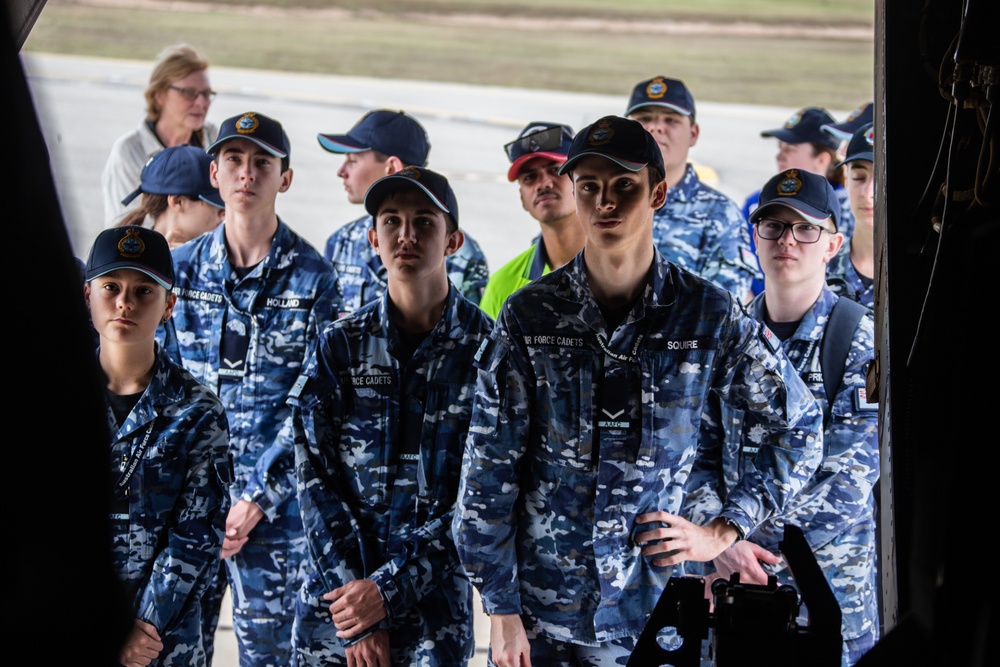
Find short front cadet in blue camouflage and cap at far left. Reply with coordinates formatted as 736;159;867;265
84;226;230;667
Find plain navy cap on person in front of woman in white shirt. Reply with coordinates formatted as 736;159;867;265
122;144;226;208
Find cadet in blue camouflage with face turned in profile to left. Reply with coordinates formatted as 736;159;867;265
316;109;489;313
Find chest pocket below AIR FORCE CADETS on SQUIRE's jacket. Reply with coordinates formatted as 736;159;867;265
529;347;595;470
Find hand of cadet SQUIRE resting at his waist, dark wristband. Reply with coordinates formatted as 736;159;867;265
635;512;737;567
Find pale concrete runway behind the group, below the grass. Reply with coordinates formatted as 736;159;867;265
22;53;804;267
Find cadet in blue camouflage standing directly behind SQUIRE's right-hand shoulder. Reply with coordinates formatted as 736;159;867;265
625;76;760;301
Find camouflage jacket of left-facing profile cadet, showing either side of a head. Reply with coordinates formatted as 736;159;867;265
323;214;490;314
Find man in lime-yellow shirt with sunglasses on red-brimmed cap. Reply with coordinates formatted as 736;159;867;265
479;121;587;319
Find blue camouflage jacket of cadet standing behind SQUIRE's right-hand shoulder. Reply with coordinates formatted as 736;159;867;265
653;164;761;301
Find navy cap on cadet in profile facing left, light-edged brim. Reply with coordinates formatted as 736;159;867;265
316;109;431;167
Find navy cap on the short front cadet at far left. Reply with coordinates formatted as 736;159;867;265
84;225;174;291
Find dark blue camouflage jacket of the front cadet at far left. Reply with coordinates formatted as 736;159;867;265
107;347;230;666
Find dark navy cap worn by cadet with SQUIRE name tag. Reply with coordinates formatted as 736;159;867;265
559;116;666;176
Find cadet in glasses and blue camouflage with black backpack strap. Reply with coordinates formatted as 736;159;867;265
685;169;879;667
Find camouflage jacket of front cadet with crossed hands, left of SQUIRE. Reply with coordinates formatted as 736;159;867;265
289;285;493;664
